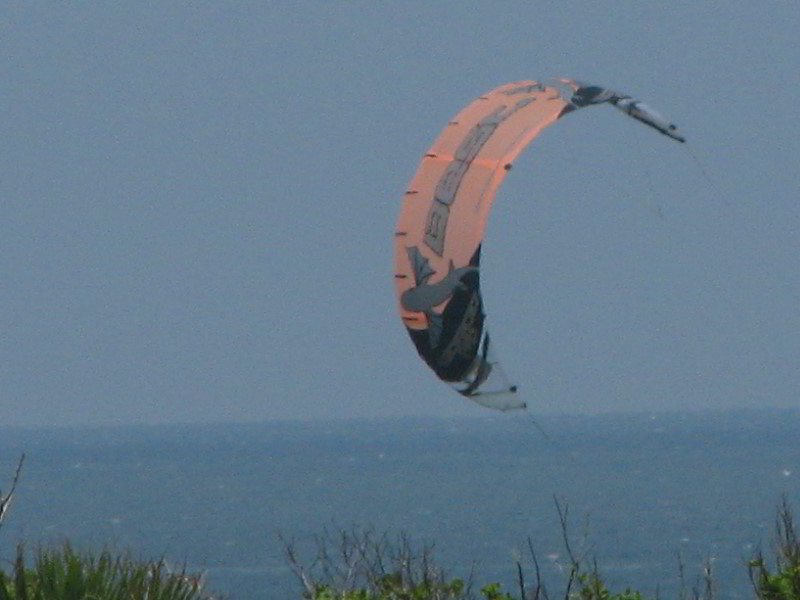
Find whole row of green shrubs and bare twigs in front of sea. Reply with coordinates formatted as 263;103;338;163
0;454;800;600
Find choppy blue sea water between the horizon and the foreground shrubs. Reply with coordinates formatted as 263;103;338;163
0;411;800;600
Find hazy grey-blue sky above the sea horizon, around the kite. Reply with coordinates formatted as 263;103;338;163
0;0;800;425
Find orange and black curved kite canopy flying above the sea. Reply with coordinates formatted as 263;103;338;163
394;79;685;410
